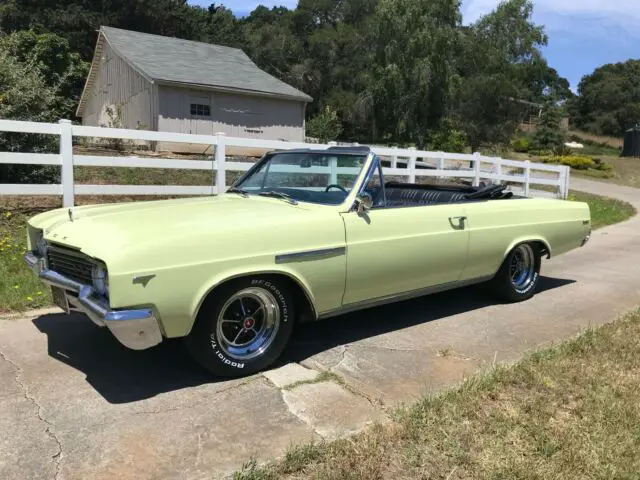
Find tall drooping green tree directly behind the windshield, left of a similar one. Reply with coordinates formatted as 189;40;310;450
367;0;461;147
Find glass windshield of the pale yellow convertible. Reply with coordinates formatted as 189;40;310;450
234;152;367;205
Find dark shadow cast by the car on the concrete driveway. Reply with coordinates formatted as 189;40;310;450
33;277;575;403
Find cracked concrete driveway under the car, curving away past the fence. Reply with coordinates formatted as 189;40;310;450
0;180;640;480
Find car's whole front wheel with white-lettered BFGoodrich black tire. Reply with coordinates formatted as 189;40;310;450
185;276;295;377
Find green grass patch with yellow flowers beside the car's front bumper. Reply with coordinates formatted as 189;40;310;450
0;210;51;313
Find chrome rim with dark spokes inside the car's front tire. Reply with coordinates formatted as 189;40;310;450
216;287;280;360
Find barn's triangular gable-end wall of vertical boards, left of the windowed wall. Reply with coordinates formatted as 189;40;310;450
82;41;154;130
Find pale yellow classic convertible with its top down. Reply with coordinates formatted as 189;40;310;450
25;147;591;377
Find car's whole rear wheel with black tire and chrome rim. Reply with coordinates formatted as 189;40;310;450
491;243;542;303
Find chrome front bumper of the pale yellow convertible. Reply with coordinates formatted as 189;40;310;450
24;252;162;350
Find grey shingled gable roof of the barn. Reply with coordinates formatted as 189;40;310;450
78;26;313;116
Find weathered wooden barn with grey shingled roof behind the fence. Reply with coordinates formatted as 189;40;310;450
77;27;312;151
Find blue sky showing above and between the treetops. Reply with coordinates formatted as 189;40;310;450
190;0;640;88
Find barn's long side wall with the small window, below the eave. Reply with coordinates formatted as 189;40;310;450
158;86;305;151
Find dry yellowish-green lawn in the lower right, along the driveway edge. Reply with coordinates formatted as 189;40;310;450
235;312;640;480
